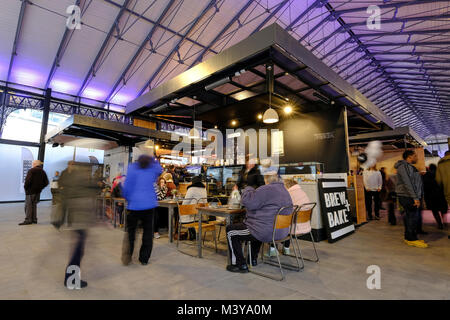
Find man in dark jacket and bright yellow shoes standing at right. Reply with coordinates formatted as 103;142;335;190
394;150;428;248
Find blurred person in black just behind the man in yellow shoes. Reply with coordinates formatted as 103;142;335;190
423;164;448;229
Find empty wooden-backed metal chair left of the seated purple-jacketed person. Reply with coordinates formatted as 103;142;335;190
177;199;217;257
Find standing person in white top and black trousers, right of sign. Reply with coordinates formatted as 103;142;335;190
363;166;383;220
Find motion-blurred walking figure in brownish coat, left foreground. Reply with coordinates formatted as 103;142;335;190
59;161;100;289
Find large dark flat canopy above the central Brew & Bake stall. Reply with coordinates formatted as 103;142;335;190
126;24;394;128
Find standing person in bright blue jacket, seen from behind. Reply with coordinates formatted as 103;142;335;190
122;155;162;265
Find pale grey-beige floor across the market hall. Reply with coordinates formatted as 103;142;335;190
0;202;450;300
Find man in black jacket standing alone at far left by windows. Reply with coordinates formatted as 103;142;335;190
19;160;48;226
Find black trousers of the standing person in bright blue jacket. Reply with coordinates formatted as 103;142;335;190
127;209;155;263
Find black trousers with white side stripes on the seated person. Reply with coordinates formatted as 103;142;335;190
226;223;261;266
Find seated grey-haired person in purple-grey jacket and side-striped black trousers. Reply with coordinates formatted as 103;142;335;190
227;167;292;273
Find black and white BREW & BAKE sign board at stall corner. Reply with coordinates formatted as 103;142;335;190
319;179;355;242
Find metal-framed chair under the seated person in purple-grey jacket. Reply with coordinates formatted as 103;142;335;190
248;206;304;281
